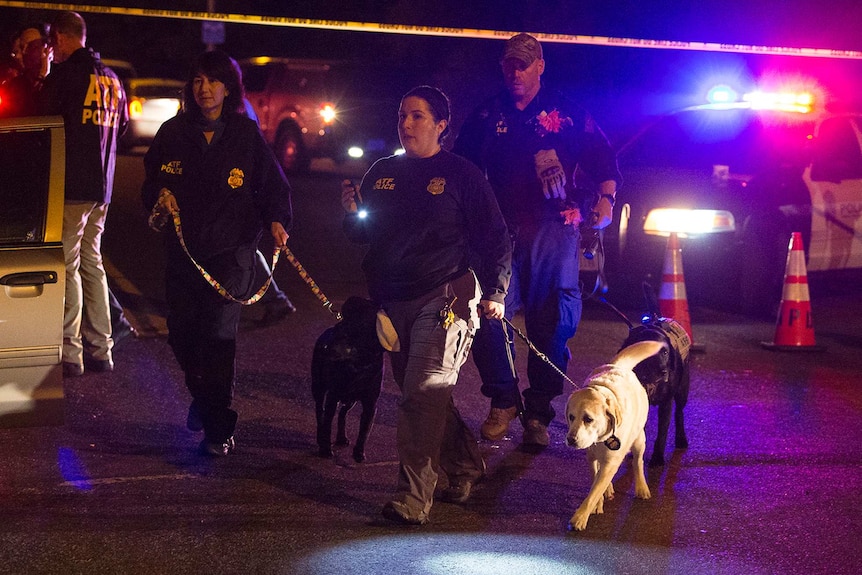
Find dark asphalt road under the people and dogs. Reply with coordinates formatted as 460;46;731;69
0;156;862;575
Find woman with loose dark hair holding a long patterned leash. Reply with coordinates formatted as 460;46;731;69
142;51;293;456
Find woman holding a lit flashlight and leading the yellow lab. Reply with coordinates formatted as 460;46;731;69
341;86;511;524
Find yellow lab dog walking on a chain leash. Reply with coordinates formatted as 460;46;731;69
566;341;664;531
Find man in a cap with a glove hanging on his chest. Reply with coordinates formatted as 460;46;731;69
452;34;620;448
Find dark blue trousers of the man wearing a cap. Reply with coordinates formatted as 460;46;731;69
473;221;583;425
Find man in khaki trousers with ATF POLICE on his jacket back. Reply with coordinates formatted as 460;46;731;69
40;12;128;376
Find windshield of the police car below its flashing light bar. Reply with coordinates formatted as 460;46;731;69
621;109;813;174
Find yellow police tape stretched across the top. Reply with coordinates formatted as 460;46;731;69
0;0;862;60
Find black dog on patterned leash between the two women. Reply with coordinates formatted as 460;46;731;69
311;296;383;463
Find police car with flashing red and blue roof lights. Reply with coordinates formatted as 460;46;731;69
604;86;862;315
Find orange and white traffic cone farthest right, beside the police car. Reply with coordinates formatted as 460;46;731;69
760;232;825;351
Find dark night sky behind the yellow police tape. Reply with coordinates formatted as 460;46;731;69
0;0;862;142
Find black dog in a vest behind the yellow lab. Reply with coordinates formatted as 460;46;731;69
620;314;691;467
